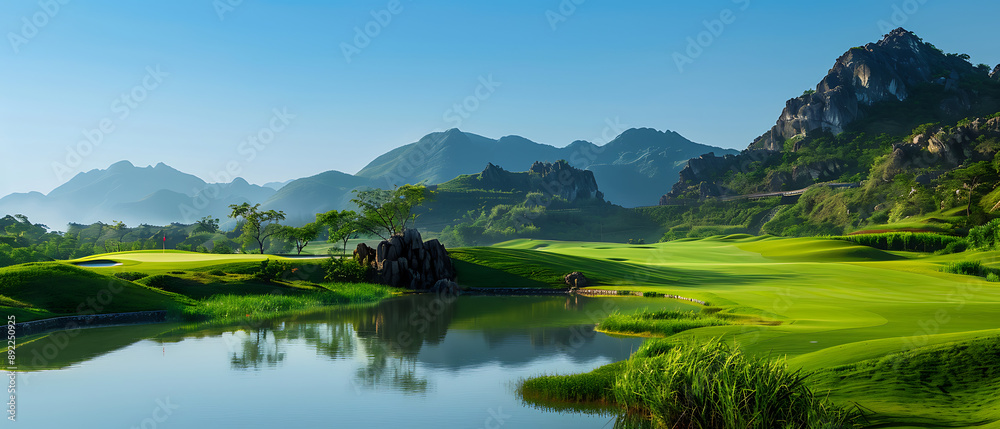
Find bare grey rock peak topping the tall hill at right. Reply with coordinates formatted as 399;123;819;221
751;28;981;151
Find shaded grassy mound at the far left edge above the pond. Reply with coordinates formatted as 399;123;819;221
0;262;191;321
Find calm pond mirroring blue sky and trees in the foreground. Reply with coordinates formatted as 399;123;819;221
18;295;694;429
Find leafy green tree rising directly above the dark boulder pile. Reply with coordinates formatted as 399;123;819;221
351;185;429;240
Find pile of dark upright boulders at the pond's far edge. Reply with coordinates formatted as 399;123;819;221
354;229;457;290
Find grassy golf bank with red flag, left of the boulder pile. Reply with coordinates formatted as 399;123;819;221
0;250;389;322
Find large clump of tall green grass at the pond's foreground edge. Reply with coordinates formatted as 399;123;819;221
611;340;864;428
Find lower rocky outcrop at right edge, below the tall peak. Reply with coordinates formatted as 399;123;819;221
882;118;1000;181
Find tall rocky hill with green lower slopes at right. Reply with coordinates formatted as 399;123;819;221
660;28;1000;205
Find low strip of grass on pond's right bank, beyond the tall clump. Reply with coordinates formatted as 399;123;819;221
597;310;731;336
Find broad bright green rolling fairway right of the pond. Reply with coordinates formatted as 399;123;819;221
456;236;1000;427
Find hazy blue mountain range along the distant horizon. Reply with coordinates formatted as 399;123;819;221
0;128;735;230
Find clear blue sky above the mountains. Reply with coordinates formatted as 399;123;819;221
0;0;1000;196
